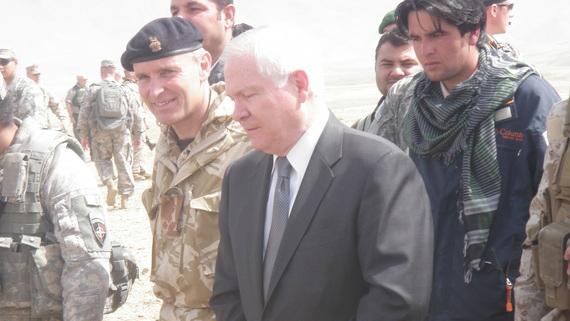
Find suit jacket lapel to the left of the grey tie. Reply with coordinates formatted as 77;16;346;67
240;153;273;311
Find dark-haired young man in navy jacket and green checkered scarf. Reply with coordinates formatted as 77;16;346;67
385;0;559;321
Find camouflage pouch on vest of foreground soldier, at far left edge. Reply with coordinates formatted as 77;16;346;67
2;153;28;202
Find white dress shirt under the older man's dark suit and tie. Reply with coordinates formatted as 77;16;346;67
263;108;329;250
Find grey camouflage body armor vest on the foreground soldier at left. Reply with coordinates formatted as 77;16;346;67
0;121;83;320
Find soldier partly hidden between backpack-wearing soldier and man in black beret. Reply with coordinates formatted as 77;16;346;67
123;70;152;180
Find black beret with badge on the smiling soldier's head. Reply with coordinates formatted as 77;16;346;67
121;17;202;71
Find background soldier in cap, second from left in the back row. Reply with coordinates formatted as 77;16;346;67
26;65;72;134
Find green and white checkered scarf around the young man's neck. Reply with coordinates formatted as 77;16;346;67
404;48;534;283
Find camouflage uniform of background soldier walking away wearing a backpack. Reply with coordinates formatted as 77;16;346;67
77;80;142;195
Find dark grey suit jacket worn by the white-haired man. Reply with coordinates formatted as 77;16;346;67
210;115;433;321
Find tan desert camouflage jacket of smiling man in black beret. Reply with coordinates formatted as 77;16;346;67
143;83;250;321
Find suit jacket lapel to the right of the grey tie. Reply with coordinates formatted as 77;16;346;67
262;114;343;301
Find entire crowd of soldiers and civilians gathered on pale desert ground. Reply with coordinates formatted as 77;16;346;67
0;0;570;321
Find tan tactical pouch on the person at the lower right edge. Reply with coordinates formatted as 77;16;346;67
538;222;570;310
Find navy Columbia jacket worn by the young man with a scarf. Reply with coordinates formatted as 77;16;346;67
410;75;560;321
